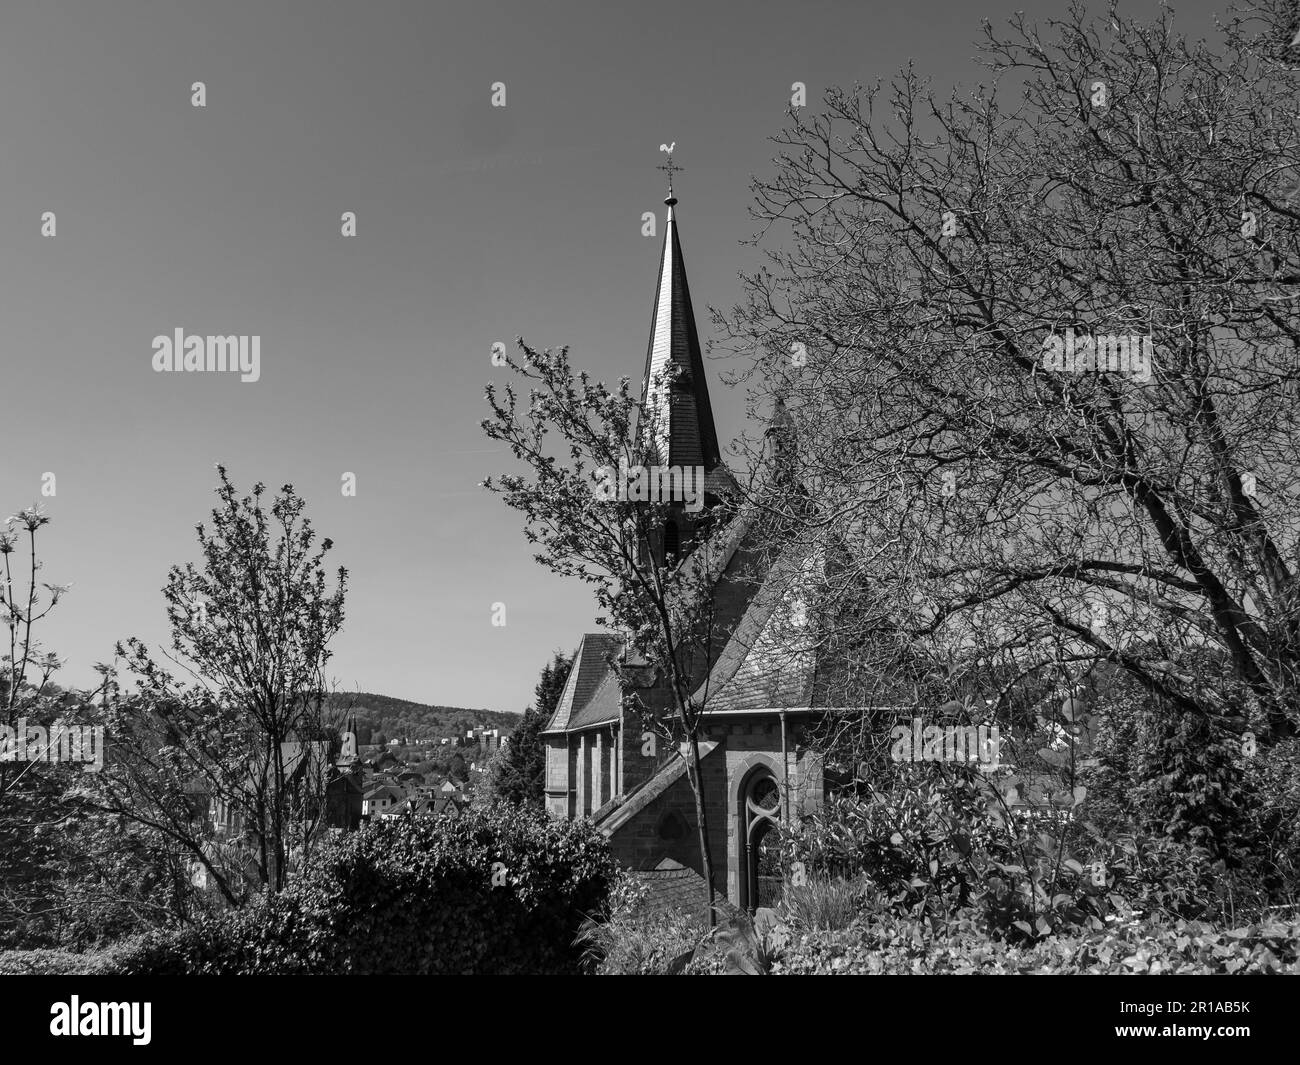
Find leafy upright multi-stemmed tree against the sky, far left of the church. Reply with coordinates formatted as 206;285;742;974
99;466;347;902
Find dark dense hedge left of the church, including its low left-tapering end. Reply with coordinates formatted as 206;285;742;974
104;808;615;974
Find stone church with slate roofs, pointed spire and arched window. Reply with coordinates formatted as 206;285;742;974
543;179;823;910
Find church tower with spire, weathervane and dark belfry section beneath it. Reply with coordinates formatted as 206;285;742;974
638;153;736;558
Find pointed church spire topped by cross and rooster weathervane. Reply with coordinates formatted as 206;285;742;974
641;160;722;473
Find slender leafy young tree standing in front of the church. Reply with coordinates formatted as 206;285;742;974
482;339;743;921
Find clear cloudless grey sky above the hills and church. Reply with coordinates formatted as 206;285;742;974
0;0;1223;710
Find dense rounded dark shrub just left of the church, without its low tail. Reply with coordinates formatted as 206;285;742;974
299;808;615;973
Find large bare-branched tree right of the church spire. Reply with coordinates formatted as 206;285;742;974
715;3;1300;740
